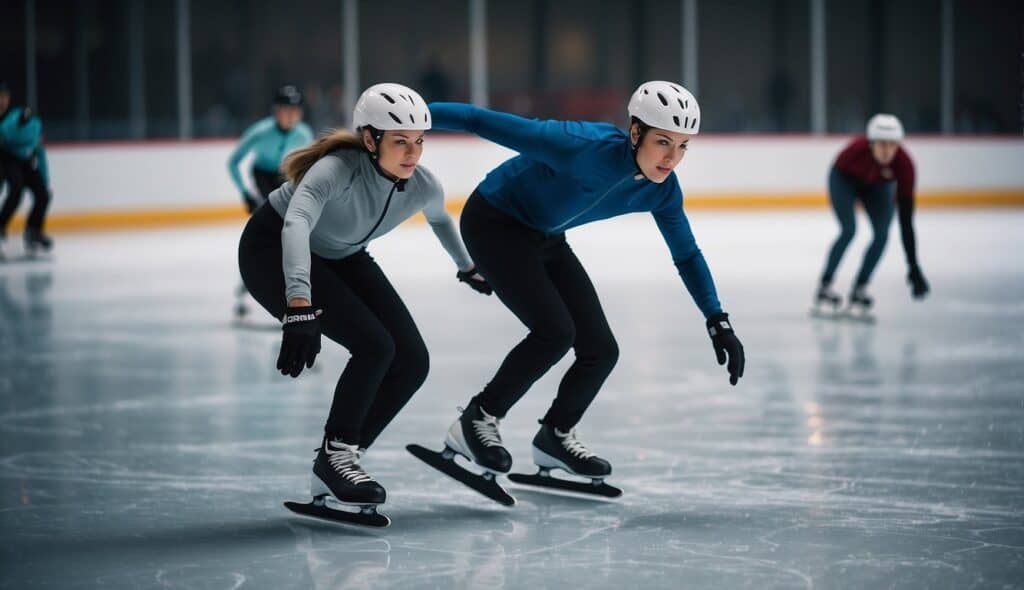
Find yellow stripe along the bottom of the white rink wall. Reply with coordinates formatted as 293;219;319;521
10;188;1024;233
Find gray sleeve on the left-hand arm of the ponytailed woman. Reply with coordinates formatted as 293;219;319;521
281;156;349;301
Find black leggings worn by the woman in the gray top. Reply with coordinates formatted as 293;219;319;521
239;204;429;448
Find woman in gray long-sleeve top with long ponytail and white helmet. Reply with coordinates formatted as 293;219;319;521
239;84;490;512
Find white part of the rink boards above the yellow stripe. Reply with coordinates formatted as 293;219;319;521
49;135;1024;213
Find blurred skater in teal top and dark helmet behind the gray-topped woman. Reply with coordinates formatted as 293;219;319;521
227;85;313;320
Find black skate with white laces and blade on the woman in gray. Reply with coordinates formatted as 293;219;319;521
285;436;391;526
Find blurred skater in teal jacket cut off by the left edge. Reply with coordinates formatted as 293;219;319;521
0;82;53;259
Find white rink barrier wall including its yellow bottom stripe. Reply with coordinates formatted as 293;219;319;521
11;135;1024;231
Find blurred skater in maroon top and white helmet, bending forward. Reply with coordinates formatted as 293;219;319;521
815;114;929;313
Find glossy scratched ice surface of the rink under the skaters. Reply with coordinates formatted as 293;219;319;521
0;210;1024;590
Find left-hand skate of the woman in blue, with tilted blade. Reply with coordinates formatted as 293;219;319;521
406;402;515;506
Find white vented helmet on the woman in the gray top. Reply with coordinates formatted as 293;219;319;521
352;83;430;131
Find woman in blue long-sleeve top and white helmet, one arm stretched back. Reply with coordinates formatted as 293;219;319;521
430;82;744;477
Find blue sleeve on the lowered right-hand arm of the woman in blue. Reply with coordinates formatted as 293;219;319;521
651;187;722;318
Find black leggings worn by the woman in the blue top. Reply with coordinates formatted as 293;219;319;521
461;192;618;430
